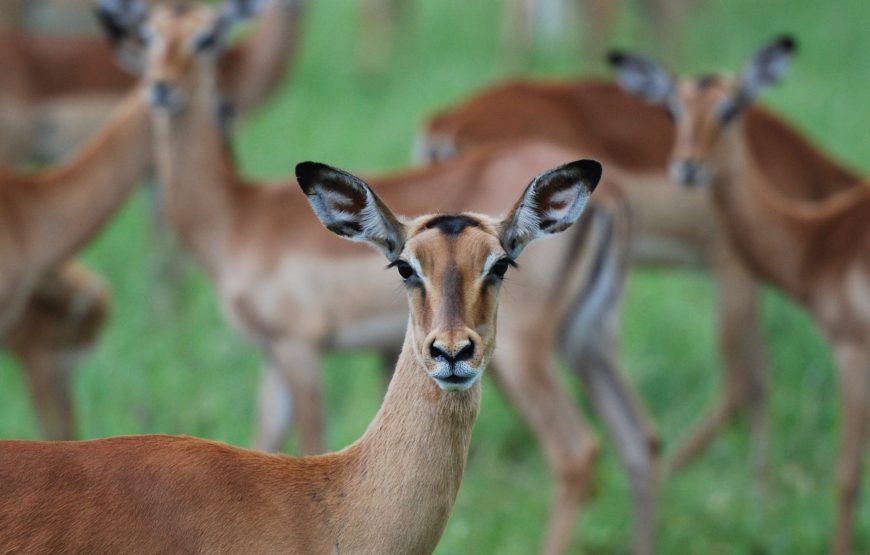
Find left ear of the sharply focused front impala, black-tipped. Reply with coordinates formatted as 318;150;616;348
296;162;405;262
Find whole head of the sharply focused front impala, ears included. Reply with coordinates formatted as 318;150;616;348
296;160;601;391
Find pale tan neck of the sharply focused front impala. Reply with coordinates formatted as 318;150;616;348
336;330;480;553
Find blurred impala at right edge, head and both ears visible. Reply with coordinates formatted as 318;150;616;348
618;37;870;554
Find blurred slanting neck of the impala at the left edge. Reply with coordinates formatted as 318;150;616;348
22;89;153;274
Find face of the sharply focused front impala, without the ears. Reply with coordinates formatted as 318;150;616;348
390;214;516;390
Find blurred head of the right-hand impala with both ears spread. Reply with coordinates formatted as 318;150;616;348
609;36;796;187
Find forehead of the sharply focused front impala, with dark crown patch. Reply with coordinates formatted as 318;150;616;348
403;215;505;281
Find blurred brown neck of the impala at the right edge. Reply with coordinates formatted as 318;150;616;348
714;119;808;301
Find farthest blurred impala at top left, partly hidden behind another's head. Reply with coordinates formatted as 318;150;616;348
0;0;302;166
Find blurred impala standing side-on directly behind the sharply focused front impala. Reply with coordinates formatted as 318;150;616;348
99;3;655;553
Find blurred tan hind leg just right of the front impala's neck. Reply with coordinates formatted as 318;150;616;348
491;327;600;555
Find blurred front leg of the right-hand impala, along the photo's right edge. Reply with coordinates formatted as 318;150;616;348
831;343;870;555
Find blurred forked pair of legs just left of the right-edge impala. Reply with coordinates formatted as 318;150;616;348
668;249;769;484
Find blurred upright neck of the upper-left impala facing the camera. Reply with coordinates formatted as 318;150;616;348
154;63;238;275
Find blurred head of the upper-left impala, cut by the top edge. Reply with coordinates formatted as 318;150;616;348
98;0;266;113
